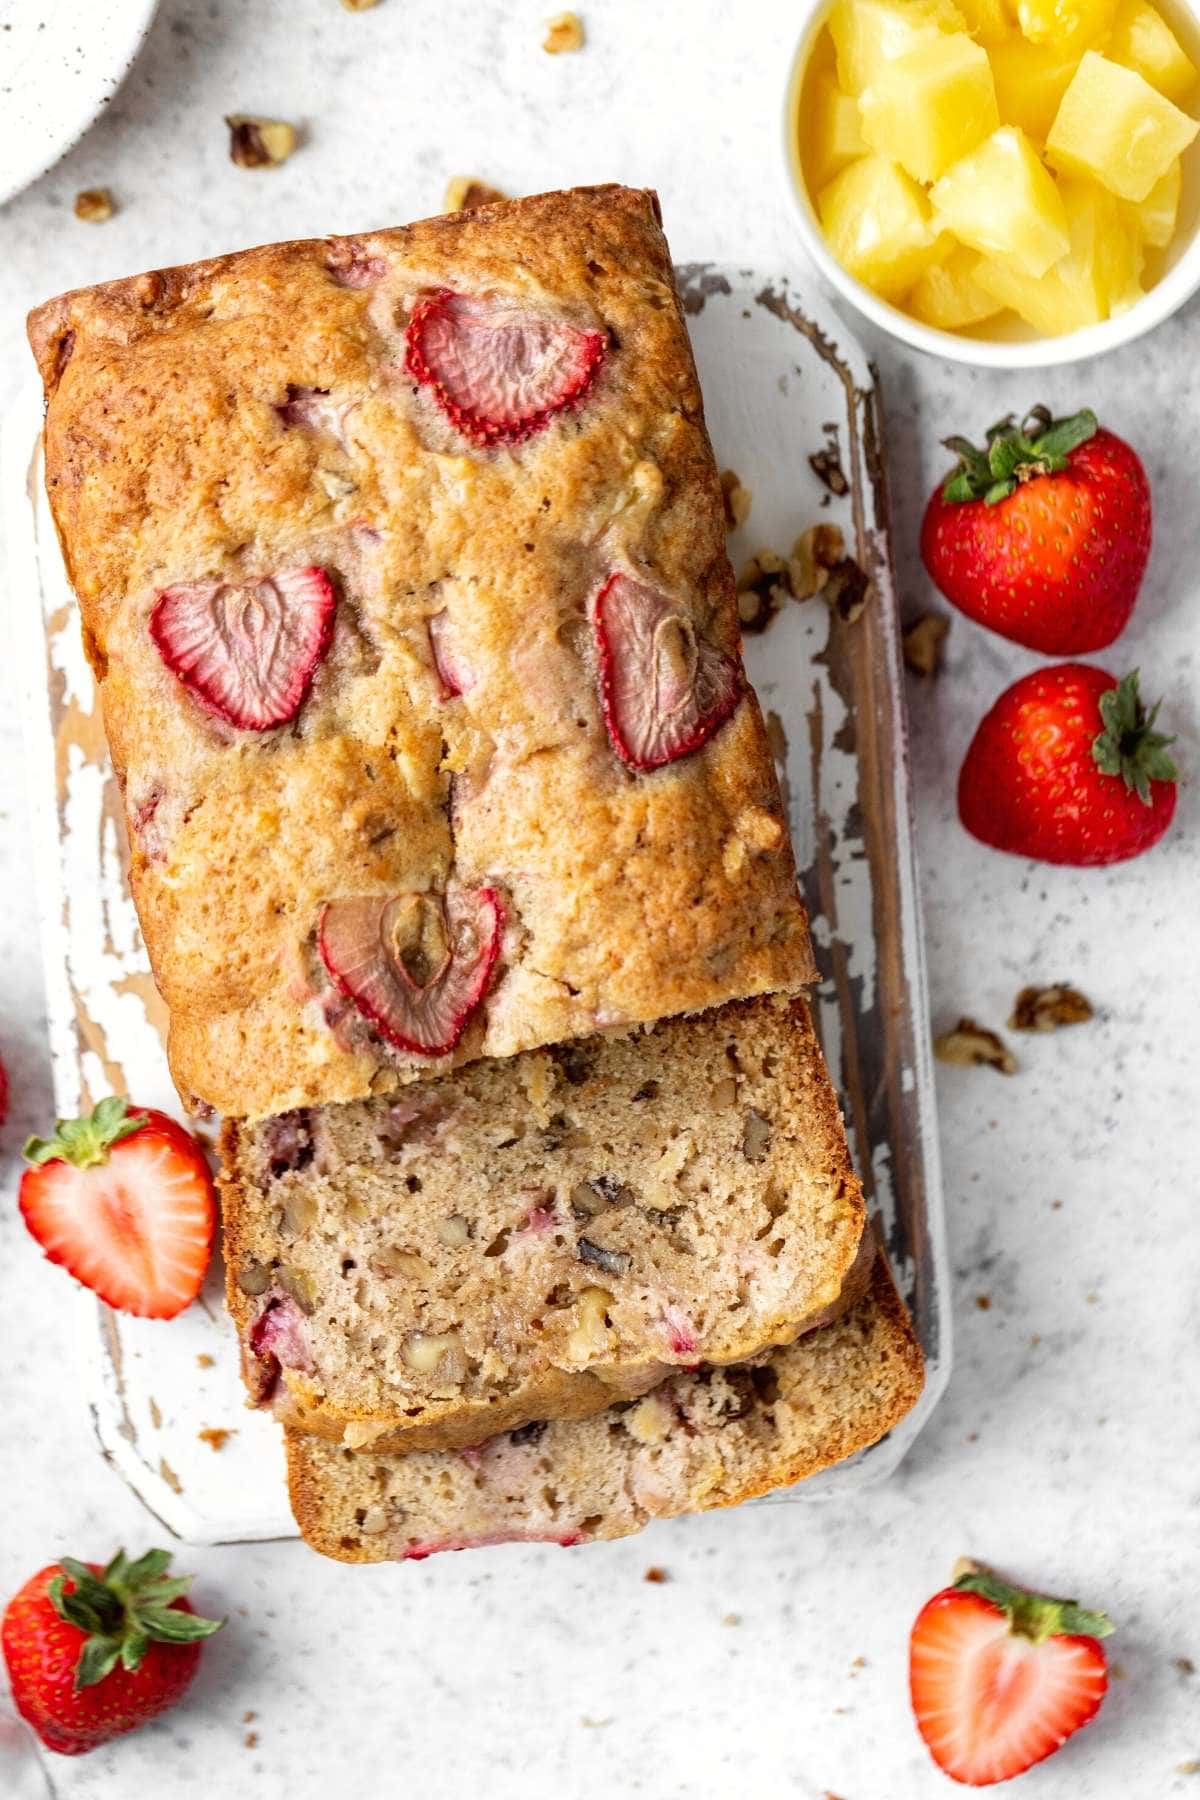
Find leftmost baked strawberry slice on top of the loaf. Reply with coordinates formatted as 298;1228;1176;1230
149;569;336;731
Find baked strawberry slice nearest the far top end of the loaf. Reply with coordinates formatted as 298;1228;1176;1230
405;288;604;445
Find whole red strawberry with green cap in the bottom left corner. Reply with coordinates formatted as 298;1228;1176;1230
0;1550;223;1757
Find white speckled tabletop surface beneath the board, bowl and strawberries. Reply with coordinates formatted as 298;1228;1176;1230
0;0;1200;1800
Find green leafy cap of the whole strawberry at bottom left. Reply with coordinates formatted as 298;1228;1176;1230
47;1550;225;1690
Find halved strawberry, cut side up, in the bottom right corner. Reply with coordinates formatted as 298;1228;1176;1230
909;1568;1112;1787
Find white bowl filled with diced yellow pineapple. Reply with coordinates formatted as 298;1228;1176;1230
786;0;1200;367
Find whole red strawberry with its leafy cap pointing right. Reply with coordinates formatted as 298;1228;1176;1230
959;662;1178;868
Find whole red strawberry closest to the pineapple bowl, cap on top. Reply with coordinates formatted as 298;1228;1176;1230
921;407;1150;657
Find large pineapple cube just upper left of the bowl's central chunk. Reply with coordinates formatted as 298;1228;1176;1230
858;31;1000;182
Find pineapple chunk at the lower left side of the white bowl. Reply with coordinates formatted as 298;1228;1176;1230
817;157;936;301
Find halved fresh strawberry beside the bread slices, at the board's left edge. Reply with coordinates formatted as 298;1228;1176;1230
20;1096;216;1319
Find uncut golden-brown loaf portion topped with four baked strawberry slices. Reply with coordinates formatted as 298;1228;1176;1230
29;187;813;1120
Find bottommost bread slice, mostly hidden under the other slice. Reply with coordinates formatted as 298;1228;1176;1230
286;1258;923;1562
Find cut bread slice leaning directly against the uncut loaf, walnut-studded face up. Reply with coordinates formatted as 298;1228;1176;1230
221;999;864;1451
